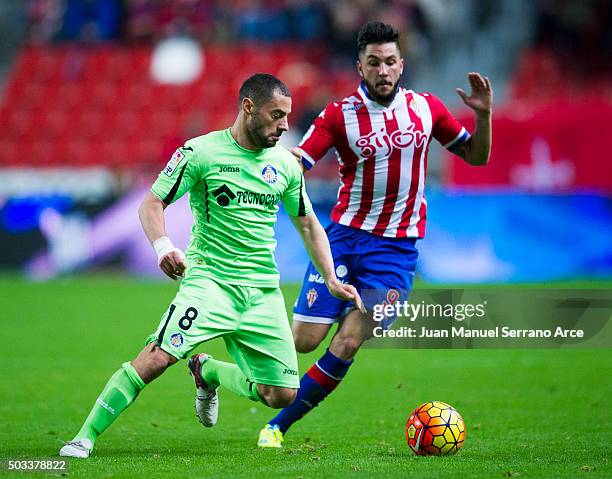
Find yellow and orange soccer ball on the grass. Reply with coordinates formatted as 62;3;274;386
406;401;466;456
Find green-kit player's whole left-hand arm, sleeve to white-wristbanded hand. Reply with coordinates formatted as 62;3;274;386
139;143;200;279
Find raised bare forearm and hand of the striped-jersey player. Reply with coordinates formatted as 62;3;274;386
453;72;493;166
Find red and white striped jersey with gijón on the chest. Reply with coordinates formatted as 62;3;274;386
299;83;469;238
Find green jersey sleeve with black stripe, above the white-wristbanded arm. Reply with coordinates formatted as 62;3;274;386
151;142;201;205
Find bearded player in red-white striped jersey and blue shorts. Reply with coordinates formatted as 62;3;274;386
258;22;493;447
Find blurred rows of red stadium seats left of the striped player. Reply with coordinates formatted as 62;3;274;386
0;45;354;169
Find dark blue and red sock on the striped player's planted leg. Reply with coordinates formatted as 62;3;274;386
269;349;353;434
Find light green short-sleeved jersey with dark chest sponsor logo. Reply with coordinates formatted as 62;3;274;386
151;128;312;288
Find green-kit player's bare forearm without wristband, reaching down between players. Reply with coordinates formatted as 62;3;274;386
291;213;366;313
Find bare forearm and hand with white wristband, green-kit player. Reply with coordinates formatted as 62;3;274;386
138;192;187;279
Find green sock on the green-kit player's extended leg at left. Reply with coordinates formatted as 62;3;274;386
75;363;145;443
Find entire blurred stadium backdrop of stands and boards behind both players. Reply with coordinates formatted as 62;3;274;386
0;0;612;282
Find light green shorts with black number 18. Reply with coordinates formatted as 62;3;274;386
147;275;300;388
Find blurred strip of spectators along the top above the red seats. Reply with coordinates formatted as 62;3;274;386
18;0;612;84
